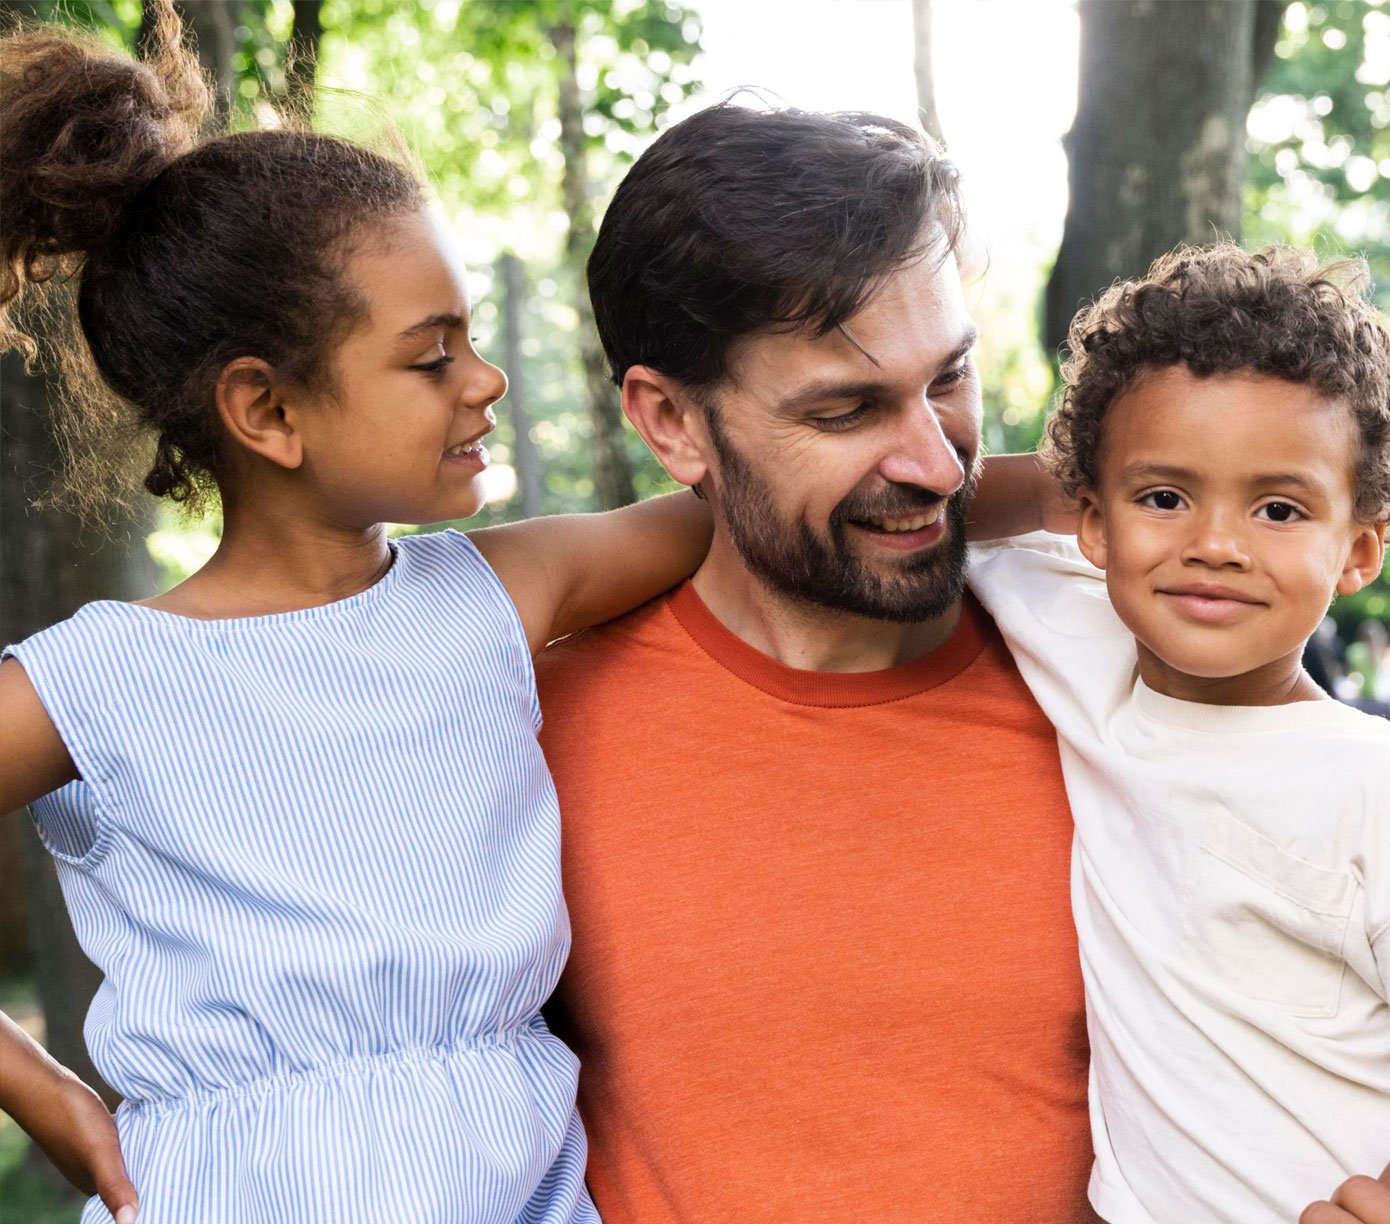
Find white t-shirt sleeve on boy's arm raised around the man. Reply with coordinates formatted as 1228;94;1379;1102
969;531;1137;738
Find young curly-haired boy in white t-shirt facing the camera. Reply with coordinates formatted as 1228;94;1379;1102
970;245;1390;1224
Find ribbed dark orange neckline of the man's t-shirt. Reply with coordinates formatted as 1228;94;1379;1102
666;581;995;707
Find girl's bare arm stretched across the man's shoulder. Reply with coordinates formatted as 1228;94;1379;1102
468;492;713;653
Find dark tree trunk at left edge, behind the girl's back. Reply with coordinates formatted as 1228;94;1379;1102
0;353;156;1105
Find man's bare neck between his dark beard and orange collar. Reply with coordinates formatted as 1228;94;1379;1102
692;532;960;671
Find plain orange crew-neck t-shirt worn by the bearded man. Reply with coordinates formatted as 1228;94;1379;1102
538;584;1094;1224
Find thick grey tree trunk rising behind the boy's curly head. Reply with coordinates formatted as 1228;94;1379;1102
1044;0;1284;349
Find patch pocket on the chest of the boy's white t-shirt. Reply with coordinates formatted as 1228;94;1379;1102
1183;813;1357;1017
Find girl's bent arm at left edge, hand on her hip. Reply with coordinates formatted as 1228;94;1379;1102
0;659;135;1224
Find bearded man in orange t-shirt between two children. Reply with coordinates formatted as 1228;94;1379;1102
539;106;1091;1224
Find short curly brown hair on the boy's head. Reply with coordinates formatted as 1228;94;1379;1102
1044;242;1390;522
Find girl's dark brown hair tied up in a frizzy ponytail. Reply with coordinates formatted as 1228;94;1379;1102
0;0;423;513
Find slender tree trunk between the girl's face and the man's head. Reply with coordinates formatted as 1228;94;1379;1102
548;21;637;510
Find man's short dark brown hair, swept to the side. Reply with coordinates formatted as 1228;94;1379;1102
588;103;963;389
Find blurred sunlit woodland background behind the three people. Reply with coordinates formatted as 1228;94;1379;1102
0;0;1390;1224
